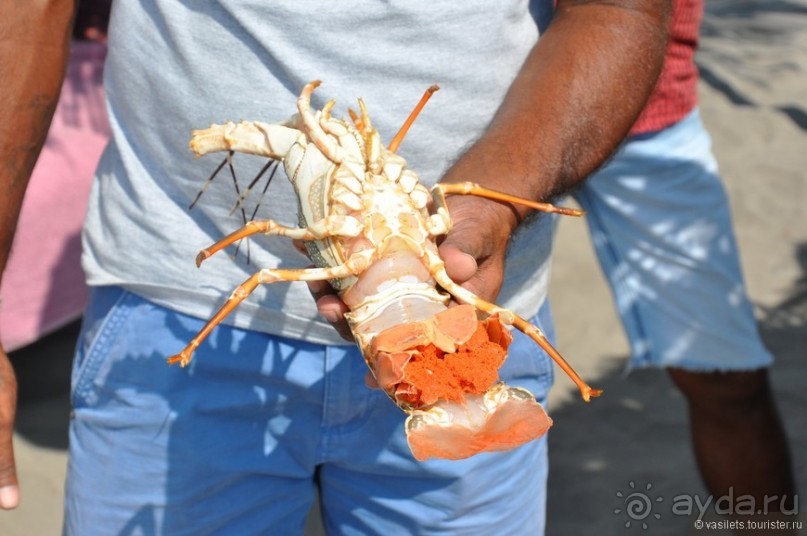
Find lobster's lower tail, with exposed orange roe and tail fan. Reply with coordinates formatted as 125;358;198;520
365;305;552;461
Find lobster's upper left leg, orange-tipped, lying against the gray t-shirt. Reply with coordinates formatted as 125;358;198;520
196;215;362;266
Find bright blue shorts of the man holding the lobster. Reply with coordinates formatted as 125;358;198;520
65;287;552;536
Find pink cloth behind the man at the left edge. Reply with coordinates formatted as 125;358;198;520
0;42;109;351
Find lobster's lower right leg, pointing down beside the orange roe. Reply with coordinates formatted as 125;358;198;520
425;249;602;402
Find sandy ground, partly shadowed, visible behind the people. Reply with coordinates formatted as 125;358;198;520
0;0;807;536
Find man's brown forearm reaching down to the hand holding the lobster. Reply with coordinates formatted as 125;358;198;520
446;0;669;224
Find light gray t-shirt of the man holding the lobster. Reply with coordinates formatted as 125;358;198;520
83;0;551;344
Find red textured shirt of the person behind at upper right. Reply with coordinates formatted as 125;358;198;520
630;0;703;135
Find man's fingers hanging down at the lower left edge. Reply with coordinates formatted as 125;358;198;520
0;349;20;510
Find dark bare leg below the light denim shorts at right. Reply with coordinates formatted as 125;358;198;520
668;368;796;510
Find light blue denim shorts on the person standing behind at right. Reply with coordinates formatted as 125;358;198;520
574;110;772;371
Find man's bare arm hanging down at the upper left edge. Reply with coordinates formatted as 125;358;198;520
0;0;75;274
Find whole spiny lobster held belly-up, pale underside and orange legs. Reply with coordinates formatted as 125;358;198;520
168;81;601;460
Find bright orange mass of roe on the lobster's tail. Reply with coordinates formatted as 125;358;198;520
399;322;507;407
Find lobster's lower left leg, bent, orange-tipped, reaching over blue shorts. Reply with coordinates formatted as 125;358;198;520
168;249;374;367
